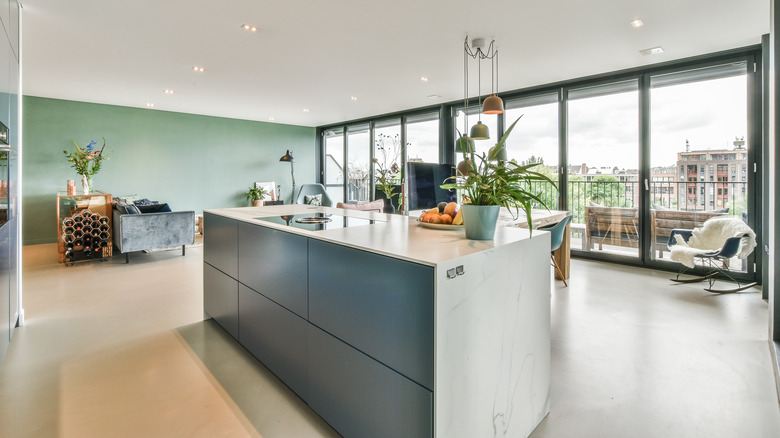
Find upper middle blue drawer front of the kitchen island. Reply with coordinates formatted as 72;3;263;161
238;223;309;318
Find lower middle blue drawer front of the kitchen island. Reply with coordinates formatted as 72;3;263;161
238;284;309;400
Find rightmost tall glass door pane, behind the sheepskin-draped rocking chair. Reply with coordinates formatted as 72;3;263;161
650;60;752;272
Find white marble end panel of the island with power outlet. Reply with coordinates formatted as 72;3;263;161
434;231;551;438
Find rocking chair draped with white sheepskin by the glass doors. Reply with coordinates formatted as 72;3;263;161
668;216;756;293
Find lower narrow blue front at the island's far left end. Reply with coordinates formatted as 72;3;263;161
203;263;238;339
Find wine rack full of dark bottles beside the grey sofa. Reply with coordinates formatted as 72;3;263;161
57;193;113;266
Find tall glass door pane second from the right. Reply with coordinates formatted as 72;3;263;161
567;79;640;257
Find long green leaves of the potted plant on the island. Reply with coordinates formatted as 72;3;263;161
441;116;555;233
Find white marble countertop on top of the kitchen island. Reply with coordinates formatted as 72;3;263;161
206;204;544;266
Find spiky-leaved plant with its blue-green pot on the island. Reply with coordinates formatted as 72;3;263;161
441;116;555;240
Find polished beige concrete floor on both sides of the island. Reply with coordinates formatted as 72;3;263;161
0;245;780;438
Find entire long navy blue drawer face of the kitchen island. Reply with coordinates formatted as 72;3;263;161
203;213;434;437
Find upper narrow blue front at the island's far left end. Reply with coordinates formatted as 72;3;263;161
203;213;238;279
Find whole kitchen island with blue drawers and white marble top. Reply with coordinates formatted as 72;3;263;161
204;205;550;437
